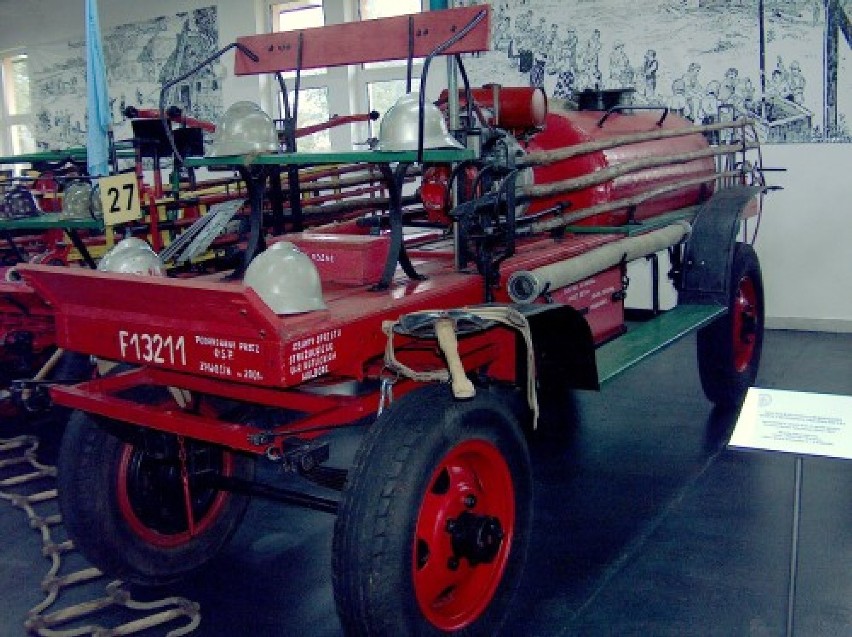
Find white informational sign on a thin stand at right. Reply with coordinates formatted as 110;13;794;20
729;387;852;460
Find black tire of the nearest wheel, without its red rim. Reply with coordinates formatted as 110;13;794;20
332;385;532;637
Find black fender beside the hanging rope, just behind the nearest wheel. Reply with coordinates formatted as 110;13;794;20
514;303;600;394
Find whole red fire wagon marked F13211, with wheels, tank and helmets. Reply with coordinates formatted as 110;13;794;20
18;7;764;636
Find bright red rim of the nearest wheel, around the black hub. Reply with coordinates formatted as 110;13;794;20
412;440;515;631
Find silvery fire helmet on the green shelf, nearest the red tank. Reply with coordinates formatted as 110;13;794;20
379;93;464;151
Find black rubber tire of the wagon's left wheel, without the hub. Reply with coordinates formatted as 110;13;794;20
58;411;254;586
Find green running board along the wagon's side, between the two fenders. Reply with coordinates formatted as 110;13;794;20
596;304;727;384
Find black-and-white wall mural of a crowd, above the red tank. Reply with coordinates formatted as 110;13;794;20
457;0;852;143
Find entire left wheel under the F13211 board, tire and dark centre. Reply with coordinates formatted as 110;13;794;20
58;412;254;586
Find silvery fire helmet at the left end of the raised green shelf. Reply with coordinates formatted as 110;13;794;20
208;101;280;157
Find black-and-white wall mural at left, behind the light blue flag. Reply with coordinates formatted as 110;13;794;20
28;7;224;150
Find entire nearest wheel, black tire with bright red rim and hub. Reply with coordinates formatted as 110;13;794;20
332;386;532;637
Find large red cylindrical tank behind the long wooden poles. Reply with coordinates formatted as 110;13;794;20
526;103;715;226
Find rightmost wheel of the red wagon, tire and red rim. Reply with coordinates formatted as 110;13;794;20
698;243;764;407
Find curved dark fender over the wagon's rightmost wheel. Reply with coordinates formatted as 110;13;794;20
679;186;762;305
